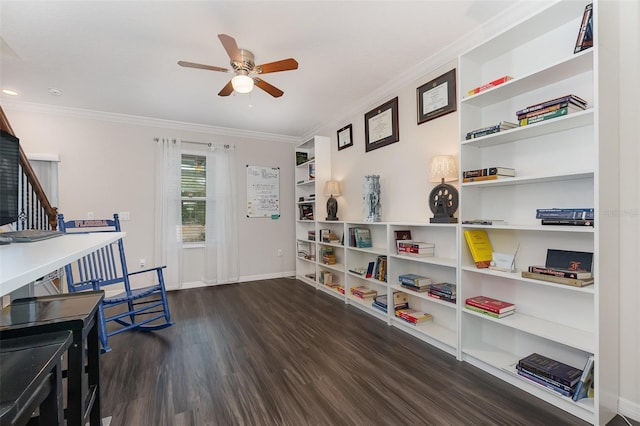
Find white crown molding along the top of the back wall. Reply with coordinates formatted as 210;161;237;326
2;98;301;144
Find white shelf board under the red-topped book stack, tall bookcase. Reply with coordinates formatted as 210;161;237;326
461;305;595;353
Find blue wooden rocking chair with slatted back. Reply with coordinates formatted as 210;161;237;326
58;214;173;353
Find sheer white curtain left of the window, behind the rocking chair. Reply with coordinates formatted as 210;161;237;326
155;138;182;290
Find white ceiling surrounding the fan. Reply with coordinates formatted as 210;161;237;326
0;0;516;137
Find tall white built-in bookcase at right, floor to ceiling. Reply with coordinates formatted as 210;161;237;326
457;0;619;424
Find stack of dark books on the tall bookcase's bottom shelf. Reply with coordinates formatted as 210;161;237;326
516;353;582;397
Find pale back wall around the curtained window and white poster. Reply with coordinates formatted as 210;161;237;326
3;104;295;283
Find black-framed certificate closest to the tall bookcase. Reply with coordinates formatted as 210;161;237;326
416;68;457;124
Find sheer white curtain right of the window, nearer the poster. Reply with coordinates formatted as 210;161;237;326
203;145;239;284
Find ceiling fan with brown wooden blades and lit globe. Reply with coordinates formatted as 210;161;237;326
178;34;298;98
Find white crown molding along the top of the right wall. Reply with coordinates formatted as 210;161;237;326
302;0;560;140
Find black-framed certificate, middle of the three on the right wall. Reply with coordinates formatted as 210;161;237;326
364;96;400;152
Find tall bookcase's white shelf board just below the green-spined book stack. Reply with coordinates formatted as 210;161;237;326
460;108;595;148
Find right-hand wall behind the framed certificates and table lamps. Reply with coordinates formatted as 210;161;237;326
319;61;458;222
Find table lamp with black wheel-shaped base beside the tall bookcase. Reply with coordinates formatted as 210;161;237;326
429;155;458;223
